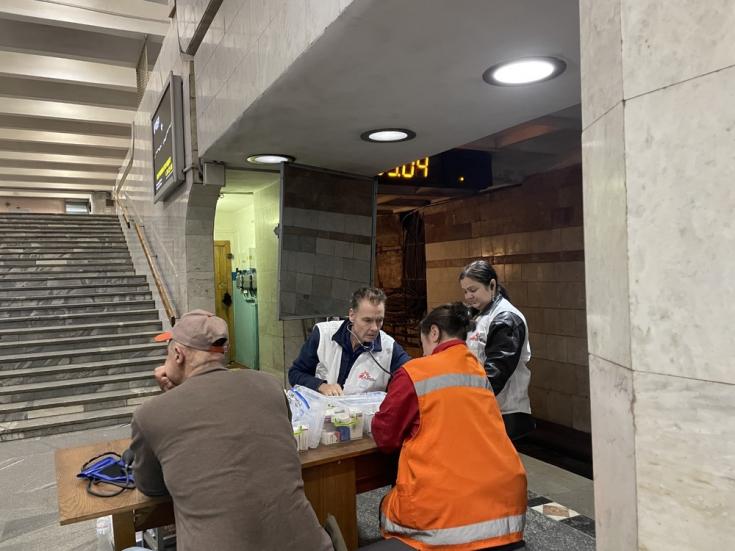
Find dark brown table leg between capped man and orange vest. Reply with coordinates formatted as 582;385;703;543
302;459;357;551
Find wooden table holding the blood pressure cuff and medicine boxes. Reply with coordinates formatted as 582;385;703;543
55;438;396;551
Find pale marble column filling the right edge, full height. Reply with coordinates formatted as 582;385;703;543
580;0;735;551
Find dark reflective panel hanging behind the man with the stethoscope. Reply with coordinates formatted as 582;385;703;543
278;164;376;320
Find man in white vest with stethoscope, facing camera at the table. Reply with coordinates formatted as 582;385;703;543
288;287;411;396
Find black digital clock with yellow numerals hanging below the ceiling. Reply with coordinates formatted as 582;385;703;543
378;149;493;189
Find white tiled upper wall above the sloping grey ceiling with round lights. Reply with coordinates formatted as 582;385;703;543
196;0;352;154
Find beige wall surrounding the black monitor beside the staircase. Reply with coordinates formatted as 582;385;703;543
116;21;219;315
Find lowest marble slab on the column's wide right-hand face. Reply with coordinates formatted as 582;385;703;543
636;372;735;551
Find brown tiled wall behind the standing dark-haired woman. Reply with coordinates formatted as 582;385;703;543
424;166;590;432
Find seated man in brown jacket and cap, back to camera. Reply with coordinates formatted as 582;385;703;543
131;310;332;551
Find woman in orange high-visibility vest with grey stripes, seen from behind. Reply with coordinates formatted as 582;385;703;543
372;303;527;550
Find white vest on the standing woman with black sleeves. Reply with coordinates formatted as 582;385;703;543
467;298;531;415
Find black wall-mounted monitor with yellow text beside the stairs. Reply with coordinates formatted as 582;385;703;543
151;73;186;203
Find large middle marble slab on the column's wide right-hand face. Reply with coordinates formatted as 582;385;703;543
624;68;735;384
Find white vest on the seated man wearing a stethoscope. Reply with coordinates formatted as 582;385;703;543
315;321;395;394
